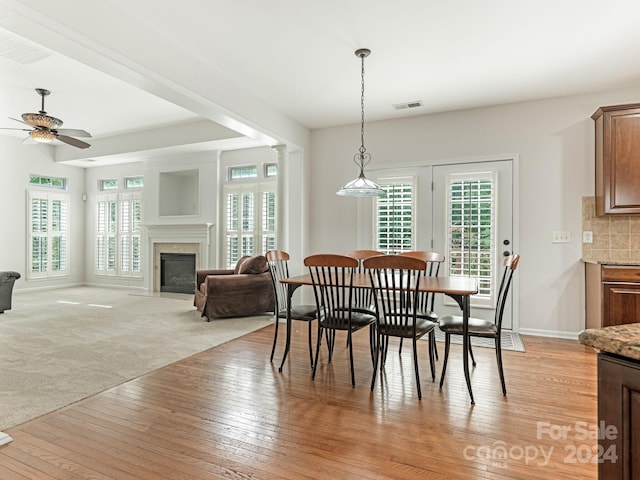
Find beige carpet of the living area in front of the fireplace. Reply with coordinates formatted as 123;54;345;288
0;287;273;430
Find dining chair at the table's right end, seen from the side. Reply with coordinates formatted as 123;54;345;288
438;254;520;395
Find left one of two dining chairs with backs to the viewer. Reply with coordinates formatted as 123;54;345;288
304;254;376;387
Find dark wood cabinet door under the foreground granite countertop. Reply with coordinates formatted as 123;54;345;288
598;354;640;480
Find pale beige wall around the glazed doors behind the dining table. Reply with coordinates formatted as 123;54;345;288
309;83;640;338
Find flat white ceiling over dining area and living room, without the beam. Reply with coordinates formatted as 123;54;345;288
0;0;640;156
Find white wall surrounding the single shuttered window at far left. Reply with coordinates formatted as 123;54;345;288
0;135;85;290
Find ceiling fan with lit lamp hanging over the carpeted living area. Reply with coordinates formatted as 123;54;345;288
2;88;91;148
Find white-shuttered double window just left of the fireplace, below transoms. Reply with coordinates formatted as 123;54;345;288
96;193;142;277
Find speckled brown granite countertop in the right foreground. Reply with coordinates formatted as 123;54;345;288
578;323;640;360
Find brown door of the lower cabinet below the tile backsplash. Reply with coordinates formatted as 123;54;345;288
602;282;640;327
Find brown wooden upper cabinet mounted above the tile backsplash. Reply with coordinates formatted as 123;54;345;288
591;103;640;216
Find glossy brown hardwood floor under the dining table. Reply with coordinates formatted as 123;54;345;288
0;325;597;480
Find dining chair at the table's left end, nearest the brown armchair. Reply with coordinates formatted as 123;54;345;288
265;250;317;367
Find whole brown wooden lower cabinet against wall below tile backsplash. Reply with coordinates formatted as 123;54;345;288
585;263;640;328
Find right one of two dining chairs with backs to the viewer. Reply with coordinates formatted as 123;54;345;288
364;255;436;399
